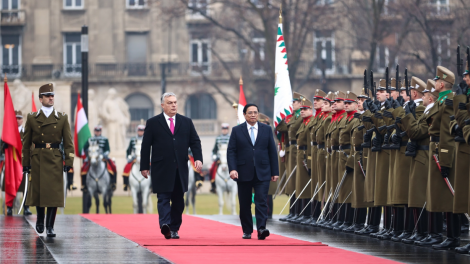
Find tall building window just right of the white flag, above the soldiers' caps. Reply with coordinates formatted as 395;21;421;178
314;31;335;74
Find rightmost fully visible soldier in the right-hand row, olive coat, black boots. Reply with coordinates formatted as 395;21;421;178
426;66;460;249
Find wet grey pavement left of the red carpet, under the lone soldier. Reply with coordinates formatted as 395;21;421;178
0;215;171;264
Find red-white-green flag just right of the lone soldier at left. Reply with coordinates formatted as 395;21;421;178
73;94;91;158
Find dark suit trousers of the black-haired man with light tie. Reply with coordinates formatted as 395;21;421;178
237;172;270;234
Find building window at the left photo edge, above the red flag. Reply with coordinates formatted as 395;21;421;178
1;35;21;77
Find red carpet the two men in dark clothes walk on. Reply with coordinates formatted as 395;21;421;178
82;214;397;264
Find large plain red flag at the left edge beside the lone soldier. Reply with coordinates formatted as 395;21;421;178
2;77;23;207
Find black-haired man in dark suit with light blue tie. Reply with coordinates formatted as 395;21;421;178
227;104;279;240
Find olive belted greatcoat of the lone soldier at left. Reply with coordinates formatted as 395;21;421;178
23;109;74;207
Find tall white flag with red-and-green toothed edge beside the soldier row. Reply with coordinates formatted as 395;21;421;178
273;17;293;132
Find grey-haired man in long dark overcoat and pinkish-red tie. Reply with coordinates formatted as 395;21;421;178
140;93;202;239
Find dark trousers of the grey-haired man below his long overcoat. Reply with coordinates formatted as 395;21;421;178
157;170;184;231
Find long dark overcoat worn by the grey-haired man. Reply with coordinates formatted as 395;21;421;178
140;113;202;193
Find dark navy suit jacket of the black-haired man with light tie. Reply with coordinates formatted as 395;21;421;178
227;122;279;181
